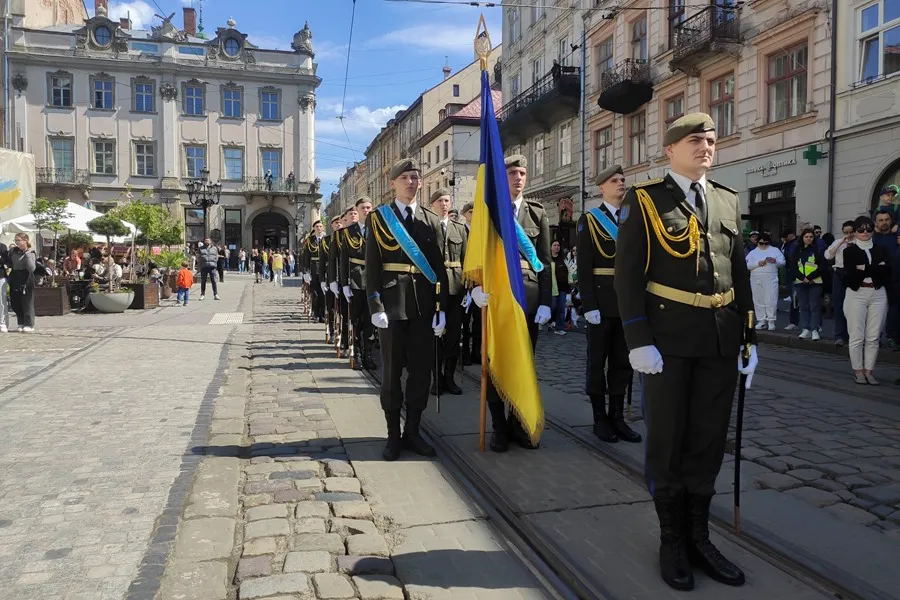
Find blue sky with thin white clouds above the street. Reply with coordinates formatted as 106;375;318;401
101;0;502;198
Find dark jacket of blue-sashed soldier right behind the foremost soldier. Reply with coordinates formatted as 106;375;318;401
575;204;619;318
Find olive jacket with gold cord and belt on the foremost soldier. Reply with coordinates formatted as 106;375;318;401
616;175;756;357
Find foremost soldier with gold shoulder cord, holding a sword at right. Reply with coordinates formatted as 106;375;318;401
615;113;757;590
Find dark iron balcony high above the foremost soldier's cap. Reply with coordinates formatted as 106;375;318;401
669;5;741;77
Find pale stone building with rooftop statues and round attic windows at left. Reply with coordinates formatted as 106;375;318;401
10;0;321;254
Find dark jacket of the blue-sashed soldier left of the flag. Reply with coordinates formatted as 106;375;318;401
365;200;447;320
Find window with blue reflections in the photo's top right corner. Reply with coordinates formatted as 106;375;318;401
859;0;900;81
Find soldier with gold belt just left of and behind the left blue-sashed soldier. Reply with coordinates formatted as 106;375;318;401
339;196;376;371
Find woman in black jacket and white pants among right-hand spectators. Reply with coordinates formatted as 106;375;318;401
844;217;891;385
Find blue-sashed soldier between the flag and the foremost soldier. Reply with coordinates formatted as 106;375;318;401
576;165;641;443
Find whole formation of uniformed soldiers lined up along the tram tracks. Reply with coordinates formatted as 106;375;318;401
303;113;757;590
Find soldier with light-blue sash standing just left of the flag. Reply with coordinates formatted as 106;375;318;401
366;159;447;460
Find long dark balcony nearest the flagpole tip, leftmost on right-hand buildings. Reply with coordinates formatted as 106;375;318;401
499;67;581;147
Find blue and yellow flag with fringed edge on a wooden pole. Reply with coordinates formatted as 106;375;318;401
463;70;544;443
